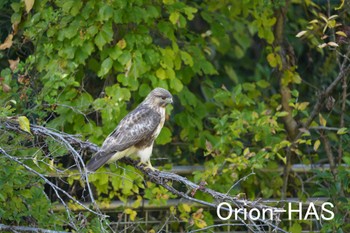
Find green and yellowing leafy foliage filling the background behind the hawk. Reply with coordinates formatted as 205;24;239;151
0;0;350;232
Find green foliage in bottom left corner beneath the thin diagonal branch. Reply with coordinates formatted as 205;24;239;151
0;158;64;230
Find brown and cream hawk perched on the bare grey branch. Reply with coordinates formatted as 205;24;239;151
86;87;173;172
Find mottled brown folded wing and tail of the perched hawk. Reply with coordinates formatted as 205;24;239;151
87;106;161;171
